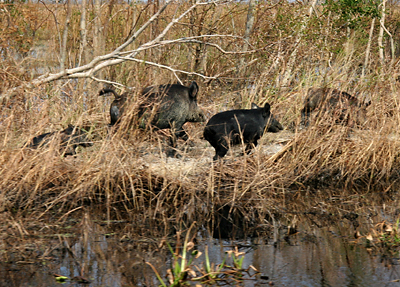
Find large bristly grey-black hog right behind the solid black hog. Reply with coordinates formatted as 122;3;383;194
139;81;205;156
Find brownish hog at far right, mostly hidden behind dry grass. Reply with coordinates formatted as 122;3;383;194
301;88;369;127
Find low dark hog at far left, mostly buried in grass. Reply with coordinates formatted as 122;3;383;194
27;125;93;156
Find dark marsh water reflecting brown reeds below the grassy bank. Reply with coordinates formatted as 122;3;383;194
0;210;400;287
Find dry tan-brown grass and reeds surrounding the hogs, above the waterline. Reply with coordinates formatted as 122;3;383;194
0;2;400;253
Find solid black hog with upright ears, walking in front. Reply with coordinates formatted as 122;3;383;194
204;103;283;160
